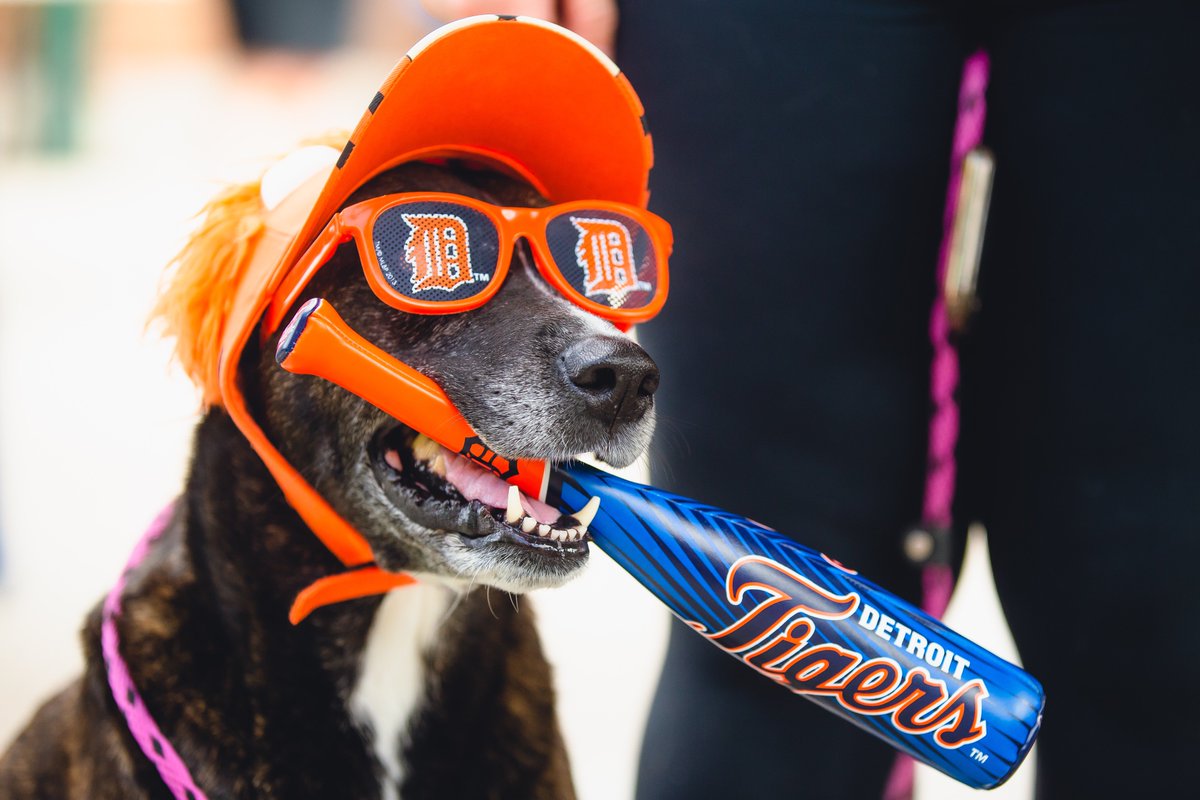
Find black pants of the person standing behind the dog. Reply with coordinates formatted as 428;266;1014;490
618;0;1200;800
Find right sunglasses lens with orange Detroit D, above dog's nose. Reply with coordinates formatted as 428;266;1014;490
546;209;659;311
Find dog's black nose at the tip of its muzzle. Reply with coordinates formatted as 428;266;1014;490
558;336;659;429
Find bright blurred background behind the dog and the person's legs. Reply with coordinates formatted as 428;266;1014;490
0;0;1032;800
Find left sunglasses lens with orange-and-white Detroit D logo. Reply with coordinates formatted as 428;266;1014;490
371;201;499;302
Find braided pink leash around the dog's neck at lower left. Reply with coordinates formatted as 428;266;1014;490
100;505;208;800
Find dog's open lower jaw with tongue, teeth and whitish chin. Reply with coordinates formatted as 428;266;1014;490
367;425;592;593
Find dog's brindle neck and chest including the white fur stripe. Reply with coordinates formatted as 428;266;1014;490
92;411;571;798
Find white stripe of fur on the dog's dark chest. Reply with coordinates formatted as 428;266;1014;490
350;581;455;800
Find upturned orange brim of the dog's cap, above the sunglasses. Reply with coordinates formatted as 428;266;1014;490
304;16;653;237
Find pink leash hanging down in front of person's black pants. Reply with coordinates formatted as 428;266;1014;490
883;50;990;800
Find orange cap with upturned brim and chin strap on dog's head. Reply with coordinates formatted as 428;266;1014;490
208;14;653;618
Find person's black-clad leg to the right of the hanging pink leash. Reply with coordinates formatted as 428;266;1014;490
960;0;1200;798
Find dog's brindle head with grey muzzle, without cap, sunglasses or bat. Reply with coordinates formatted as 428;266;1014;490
253;163;659;591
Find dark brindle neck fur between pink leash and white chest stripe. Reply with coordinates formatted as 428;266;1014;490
108;411;380;796
